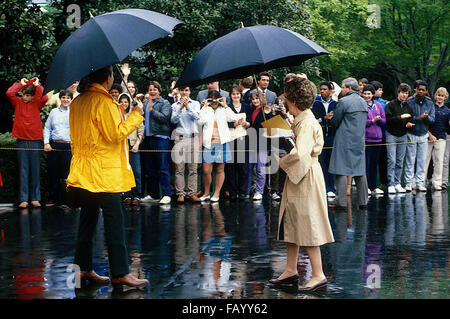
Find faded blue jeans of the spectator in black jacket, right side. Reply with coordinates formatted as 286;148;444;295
386;131;407;186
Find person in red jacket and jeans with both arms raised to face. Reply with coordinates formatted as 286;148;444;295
6;78;48;208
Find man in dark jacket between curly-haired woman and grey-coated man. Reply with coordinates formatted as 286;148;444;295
312;82;337;197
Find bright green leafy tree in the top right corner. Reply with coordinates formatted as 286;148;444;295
371;0;450;92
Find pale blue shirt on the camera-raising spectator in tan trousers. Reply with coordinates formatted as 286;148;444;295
170;99;200;136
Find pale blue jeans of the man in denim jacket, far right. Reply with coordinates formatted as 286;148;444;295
405;133;428;186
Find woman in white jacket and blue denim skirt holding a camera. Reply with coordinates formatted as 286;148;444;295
199;91;246;202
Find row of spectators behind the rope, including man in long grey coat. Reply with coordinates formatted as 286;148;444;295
7;68;450;208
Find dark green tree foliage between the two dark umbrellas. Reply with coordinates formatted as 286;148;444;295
120;0;317;91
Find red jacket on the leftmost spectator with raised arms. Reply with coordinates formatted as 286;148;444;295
6;82;48;141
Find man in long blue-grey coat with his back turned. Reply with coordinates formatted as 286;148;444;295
328;78;368;209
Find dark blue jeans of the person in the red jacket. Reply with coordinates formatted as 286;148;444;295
16;139;42;202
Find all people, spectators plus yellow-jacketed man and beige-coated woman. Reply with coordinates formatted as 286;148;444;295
7;65;450;292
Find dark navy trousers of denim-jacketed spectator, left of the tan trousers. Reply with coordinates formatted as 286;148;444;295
144;136;172;199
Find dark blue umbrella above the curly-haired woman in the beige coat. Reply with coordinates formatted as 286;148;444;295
177;25;329;87
